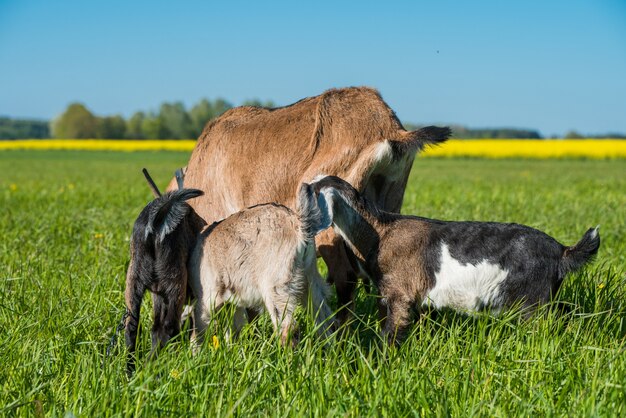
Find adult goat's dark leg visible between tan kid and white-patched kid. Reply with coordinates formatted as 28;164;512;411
316;232;357;324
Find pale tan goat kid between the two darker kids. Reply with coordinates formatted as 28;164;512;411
188;184;332;351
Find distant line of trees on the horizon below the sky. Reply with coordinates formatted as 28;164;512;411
0;103;626;139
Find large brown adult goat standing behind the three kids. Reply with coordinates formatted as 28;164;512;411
168;87;450;319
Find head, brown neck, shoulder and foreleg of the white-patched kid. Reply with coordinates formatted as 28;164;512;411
313;177;434;341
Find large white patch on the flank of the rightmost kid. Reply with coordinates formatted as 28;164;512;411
423;243;509;311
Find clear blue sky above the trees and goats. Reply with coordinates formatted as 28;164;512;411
0;0;626;135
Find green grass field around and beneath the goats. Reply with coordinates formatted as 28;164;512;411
0;151;626;417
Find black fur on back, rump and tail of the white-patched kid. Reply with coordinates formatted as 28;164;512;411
416;217;600;306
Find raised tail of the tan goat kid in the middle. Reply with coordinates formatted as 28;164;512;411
296;183;332;242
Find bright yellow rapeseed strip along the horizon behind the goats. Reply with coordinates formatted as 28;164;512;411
0;139;626;159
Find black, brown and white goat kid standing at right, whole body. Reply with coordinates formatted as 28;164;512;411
312;176;600;340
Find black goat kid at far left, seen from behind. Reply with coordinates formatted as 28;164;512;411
125;189;205;374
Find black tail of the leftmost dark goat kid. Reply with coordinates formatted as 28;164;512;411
145;189;204;242
